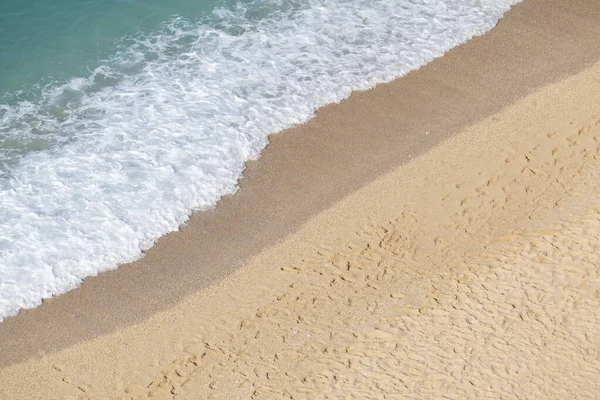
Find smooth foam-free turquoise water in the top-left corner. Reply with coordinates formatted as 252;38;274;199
0;0;217;98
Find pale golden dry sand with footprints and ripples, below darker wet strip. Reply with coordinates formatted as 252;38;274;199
0;50;600;400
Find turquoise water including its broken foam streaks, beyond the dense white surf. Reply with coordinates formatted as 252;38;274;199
0;0;300;169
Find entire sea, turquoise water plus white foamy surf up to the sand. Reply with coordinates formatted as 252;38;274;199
0;0;519;320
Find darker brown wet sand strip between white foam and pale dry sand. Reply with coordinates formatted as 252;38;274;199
0;1;600;367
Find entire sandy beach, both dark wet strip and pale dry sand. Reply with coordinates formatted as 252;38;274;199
0;0;600;399
